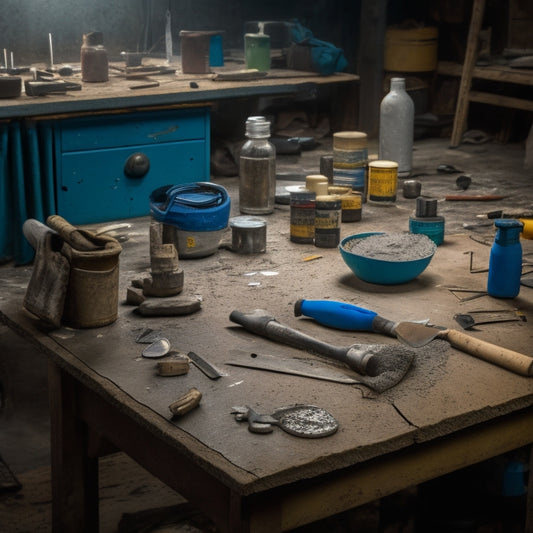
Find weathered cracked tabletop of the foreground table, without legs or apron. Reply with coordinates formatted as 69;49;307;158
0;178;533;494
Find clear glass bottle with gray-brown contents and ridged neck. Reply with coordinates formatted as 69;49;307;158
239;117;276;215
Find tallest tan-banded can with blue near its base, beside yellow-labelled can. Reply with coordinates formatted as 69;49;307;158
333;131;368;201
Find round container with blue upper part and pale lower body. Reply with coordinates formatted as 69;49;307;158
150;182;231;258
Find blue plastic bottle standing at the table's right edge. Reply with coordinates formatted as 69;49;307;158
487;218;523;298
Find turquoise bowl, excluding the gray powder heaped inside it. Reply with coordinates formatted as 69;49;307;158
339;232;437;285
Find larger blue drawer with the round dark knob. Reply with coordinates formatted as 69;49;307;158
57;139;209;224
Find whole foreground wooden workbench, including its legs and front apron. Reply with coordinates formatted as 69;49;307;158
0;179;533;533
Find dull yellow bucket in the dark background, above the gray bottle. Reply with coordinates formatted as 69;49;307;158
384;26;439;72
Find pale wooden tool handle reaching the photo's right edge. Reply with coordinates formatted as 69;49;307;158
439;329;533;377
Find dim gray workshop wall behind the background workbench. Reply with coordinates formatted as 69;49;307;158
0;0;360;72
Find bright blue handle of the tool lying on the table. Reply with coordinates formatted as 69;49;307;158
294;299;377;331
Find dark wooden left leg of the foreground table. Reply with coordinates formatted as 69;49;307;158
48;362;99;532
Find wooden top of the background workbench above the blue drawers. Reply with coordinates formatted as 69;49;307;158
0;65;359;119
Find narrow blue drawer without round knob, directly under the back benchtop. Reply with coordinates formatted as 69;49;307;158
58;107;209;153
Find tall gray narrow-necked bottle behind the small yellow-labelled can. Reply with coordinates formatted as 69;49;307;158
378;78;415;178
